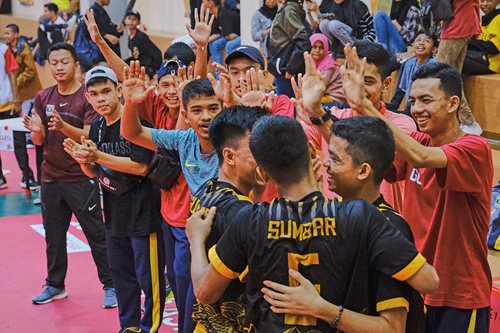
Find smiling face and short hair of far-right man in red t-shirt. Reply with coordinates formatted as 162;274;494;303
410;78;460;137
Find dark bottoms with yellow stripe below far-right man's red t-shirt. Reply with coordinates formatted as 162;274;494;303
425;306;490;333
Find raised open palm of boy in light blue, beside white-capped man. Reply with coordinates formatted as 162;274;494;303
122;60;155;104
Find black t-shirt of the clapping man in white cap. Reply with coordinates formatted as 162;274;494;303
89;117;162;237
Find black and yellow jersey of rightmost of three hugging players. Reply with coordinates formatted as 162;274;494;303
369;196;425;333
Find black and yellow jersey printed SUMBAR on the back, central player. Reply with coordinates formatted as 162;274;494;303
209;192;425;333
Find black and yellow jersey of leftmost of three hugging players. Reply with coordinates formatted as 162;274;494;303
190;179;252;333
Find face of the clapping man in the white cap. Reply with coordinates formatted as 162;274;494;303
85;80;120;118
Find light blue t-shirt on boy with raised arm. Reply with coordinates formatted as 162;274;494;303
151;128;219;195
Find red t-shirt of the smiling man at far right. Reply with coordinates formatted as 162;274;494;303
387;132;493;309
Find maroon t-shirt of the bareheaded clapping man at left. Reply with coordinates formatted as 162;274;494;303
34;85;99;182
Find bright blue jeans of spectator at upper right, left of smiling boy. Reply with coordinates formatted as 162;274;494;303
373;10;408;58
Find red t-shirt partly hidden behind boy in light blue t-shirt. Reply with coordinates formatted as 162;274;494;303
139;91;191;228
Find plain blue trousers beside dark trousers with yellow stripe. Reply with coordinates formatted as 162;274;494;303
162;221;196;333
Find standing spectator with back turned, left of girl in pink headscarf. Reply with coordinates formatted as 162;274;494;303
267;0;311;97
